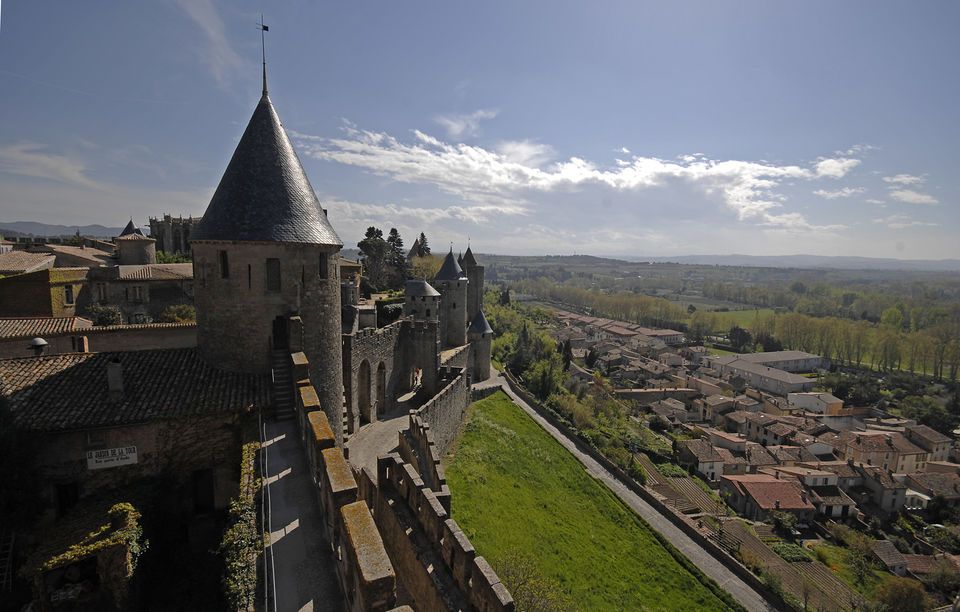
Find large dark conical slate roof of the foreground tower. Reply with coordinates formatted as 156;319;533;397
190;92;343;246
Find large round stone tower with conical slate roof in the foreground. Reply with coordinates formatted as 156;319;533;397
191;73;343;439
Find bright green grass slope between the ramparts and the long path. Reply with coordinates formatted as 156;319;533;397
446;392;736;610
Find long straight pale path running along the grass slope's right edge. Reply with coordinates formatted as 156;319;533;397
488;374;776;612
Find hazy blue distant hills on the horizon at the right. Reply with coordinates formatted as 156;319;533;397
623;255;960;272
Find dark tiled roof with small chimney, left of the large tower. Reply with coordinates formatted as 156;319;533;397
0;348;270;431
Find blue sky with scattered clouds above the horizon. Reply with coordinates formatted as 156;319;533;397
0;0;960;258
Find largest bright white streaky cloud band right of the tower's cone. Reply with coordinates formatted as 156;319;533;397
293;125;859;231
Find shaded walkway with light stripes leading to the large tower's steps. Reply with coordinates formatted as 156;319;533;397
257;420;344;612
